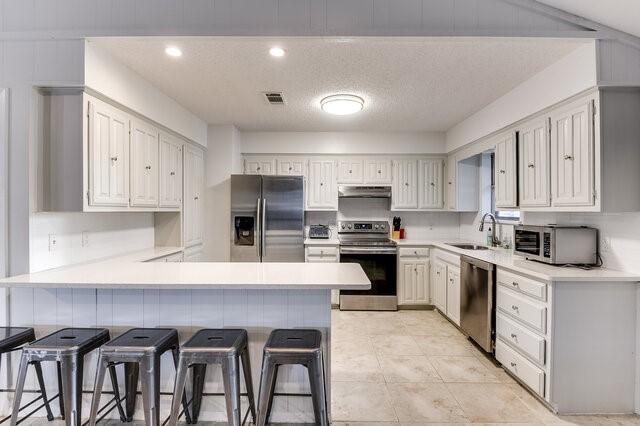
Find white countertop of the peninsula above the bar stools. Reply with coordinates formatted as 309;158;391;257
0;247;371;290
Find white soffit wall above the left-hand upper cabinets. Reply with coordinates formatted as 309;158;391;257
84;40;207;147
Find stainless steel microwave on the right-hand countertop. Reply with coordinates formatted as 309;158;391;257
513;225;598;265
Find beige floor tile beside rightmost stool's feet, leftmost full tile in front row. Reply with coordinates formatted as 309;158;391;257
331;382;397;422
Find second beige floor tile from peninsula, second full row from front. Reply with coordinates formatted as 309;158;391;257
378;355;442;383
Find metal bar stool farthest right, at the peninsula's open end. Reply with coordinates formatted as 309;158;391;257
257;329;329;426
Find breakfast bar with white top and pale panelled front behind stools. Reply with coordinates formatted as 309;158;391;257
0;249;370;422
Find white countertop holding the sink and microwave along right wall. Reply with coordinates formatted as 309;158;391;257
394;239;640;282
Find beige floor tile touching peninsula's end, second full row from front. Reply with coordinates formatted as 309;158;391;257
331;352;384;383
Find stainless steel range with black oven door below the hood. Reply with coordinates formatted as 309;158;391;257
338;221;398;311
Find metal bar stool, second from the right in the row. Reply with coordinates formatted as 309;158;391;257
169;329;256;426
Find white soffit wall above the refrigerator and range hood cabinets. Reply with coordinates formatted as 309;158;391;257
241;132;445;154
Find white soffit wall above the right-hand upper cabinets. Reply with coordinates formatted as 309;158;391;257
446;42;597;152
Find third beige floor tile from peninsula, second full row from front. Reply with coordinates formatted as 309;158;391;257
429;356;500;383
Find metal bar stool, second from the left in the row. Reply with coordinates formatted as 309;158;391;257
11;328;124;426
